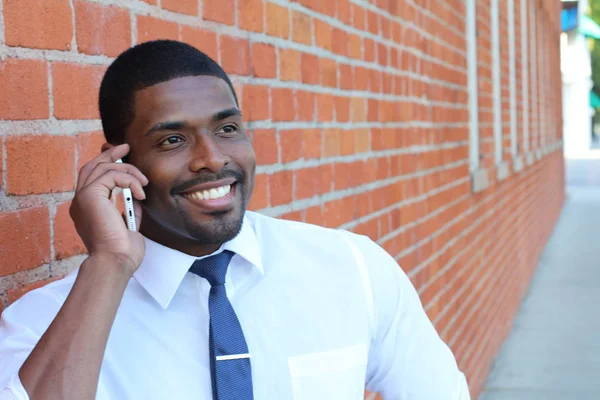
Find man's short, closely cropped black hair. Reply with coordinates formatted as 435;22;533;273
98;40;239;145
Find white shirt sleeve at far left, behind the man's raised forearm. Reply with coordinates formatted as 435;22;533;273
0;287;62;400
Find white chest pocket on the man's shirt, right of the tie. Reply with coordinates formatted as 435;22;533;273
288;344;367;400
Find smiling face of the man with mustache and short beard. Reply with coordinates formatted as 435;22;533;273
126;76;256;255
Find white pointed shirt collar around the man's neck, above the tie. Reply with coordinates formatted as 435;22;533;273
133;216;264;309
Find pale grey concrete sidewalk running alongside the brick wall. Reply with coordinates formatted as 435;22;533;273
480;156;600;400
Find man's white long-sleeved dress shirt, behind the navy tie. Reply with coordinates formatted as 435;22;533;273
0;212;469;400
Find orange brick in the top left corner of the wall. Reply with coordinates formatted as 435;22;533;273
3;0;73;50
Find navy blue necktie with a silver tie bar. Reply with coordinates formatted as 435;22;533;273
190;251;254;400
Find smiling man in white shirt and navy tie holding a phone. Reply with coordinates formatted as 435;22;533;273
0;41;469;400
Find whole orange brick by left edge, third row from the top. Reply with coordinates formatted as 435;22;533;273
6;135;75;195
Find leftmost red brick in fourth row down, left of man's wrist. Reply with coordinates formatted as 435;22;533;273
0;207;50;276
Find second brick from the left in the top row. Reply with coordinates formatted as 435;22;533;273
75;0;131;57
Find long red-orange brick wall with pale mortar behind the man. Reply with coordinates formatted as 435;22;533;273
0;0;564;397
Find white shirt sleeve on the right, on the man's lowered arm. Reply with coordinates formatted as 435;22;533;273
344;234;470;400
